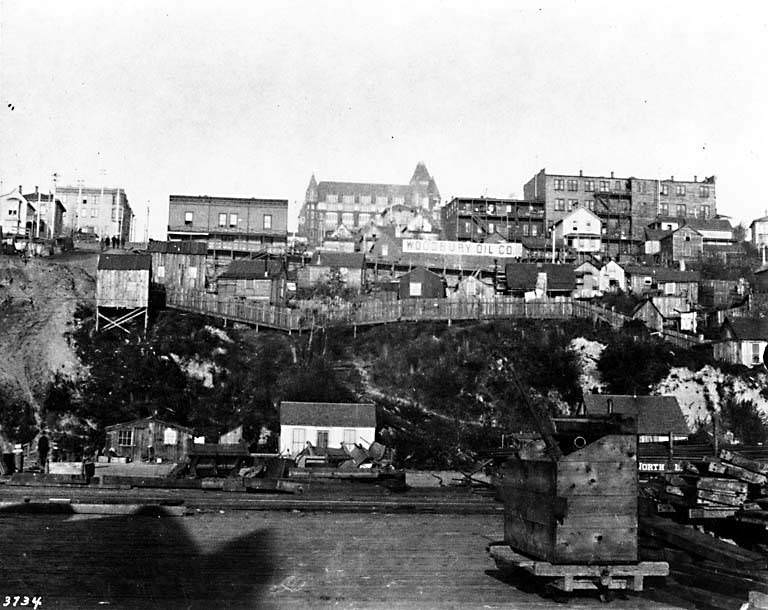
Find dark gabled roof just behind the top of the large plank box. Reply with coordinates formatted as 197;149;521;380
584;394;689;435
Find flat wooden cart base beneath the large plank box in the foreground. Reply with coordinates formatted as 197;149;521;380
488;543;669;592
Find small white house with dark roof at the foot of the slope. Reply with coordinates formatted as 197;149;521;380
280;402;376;455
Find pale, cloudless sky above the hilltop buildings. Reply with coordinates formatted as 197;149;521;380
0;0;768;239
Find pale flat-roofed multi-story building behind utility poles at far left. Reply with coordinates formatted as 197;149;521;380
56;186;133;241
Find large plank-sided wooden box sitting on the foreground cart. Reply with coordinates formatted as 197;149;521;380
500;435;637;564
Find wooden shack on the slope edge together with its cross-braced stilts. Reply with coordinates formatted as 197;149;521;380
96;254;152;333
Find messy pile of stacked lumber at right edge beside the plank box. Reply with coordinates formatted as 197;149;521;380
645;450;768;516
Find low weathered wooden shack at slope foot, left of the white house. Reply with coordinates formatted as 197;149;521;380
104;416;193;462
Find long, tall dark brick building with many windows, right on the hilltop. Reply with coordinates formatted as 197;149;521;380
523;169;717;256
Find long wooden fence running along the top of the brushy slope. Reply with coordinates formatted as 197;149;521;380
166;291;631;333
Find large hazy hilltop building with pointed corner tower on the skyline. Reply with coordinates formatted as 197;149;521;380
298;162;440;246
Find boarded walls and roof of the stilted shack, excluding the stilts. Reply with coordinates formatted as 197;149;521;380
96;254;152;309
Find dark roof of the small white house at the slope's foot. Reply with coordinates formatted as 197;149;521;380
280;402;376;426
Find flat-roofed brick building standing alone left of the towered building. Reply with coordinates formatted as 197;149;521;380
168;195;288;257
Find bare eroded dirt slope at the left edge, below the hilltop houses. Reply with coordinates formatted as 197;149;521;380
0;255;96;413
